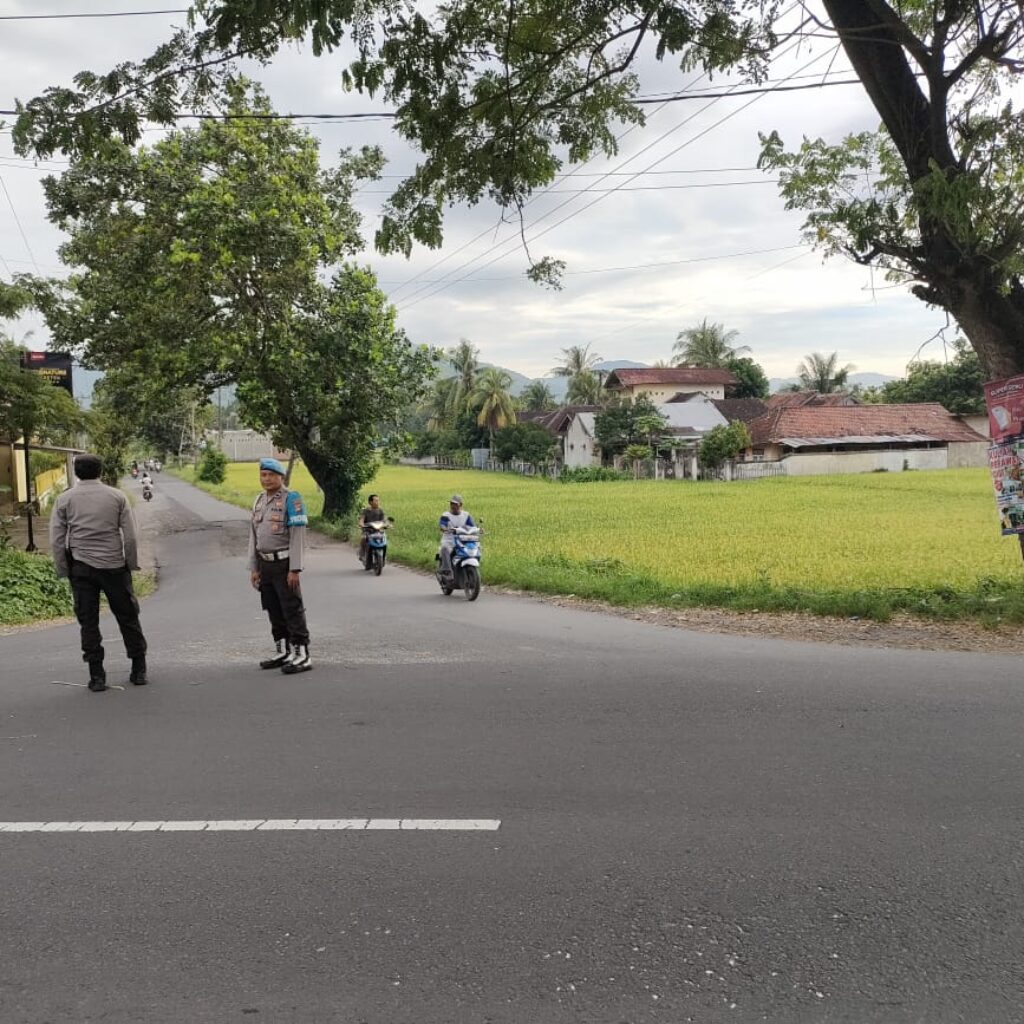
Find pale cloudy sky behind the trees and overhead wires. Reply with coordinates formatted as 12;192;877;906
0;0;954;377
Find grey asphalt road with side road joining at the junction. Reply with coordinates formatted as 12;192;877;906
0;475;1024;1024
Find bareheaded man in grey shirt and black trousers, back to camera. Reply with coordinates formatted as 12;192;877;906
50;455;147;692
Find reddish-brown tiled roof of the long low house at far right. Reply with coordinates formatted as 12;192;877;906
750;401;985;447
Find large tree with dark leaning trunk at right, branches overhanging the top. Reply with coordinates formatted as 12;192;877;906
15;0;1024;374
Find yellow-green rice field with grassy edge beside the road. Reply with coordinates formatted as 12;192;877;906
174;463;1024;625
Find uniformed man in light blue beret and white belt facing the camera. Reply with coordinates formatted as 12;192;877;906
249;459;313;676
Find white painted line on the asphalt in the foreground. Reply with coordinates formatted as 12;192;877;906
0;818;501;833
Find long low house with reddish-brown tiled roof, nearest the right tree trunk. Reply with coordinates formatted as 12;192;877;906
748;402;988;476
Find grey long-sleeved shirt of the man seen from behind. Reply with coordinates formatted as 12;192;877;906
50;480;138;577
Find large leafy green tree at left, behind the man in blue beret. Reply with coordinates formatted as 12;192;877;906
30;84;428;518
